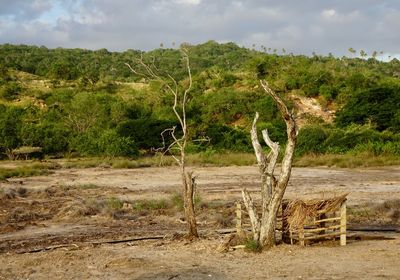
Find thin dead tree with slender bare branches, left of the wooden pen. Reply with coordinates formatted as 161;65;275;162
126;48;198;238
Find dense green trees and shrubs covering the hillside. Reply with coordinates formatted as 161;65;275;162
0;41;400;161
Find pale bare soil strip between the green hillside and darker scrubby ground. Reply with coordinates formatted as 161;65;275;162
0;166;400;204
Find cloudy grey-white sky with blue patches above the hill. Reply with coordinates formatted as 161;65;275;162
0;0;400;56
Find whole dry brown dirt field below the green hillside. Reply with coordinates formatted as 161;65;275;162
0;166;400;279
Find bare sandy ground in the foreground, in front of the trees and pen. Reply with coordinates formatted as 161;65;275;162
0;239;400;279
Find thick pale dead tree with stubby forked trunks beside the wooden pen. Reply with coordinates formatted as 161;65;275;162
242;80;297;248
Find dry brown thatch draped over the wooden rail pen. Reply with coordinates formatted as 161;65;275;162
283;193;348;230
